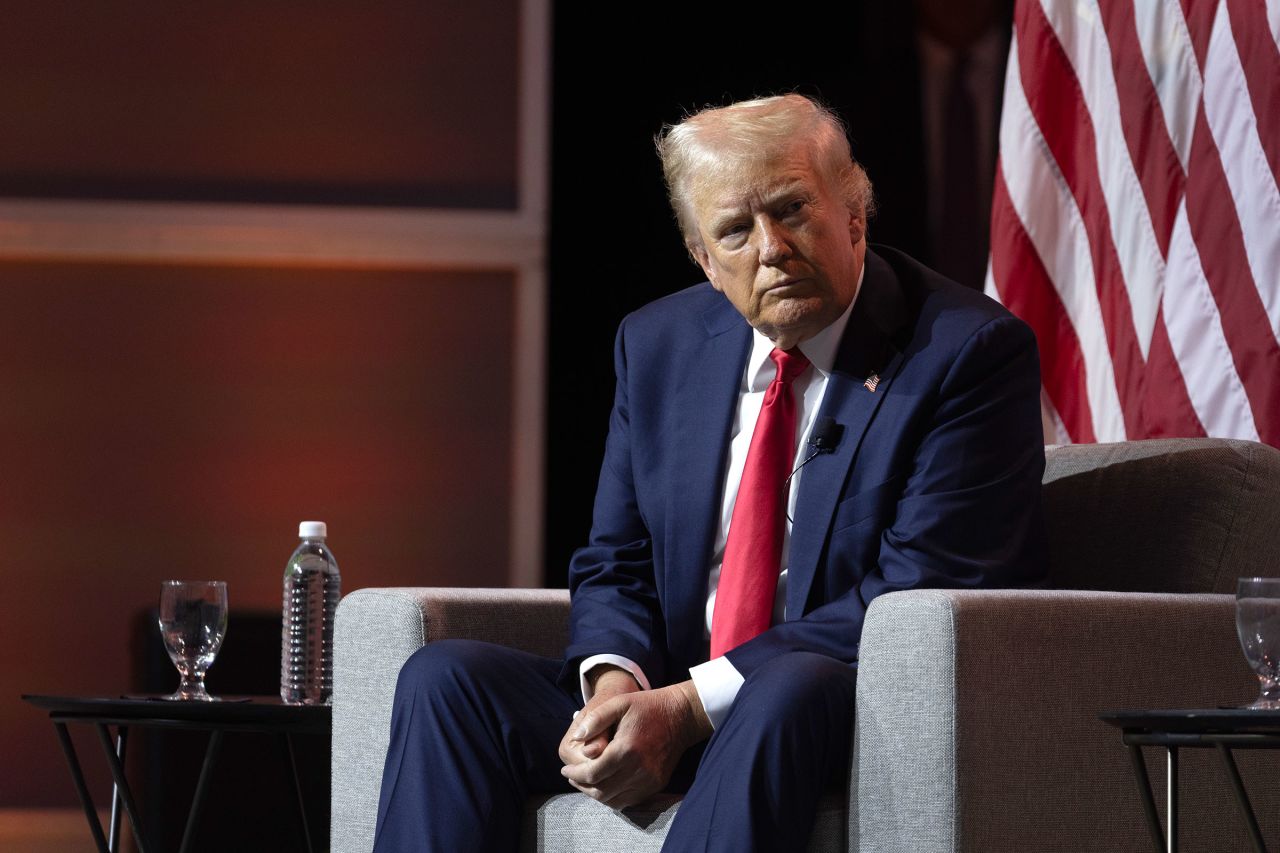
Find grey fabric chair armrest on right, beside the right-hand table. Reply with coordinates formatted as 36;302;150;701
850;590;1259;853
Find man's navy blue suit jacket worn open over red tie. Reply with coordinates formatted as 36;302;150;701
561;247;1046;693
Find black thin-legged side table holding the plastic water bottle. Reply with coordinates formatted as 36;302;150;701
22;695;332;853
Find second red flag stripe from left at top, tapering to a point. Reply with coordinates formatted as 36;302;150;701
1102;3;1185;252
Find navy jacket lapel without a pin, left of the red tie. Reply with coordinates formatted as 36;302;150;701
666;300;751;654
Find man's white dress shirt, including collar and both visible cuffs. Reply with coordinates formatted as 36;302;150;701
579;274;861;727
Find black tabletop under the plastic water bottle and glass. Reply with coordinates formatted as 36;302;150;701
22;694;333;729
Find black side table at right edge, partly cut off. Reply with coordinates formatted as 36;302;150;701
1098;708;1280;853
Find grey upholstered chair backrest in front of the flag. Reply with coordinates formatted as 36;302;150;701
1044;439;1280;593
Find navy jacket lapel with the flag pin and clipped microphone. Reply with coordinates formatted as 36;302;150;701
787;251;908;620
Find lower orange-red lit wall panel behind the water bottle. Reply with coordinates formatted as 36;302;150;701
0;263;515;807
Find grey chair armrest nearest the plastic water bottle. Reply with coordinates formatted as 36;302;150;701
330;587;568;853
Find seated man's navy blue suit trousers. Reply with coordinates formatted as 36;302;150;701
374;640;856;853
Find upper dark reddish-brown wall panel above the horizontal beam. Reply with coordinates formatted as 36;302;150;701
0;0;520;209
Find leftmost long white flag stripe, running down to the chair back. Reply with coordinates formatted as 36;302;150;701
992;36;1125;442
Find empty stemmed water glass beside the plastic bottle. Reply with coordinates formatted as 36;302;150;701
160;580;227;702
